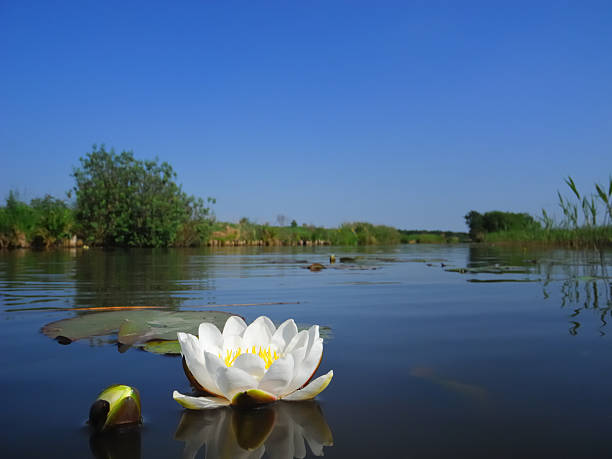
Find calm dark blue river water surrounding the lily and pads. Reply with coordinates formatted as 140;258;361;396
0;246;612;458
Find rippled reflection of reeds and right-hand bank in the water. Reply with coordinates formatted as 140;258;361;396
468;246;612;335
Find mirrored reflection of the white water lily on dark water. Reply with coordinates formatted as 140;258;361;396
174;401;333;459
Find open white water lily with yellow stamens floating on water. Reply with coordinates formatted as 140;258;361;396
173;316;334;410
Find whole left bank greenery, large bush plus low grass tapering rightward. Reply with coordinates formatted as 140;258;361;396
0;146;467;248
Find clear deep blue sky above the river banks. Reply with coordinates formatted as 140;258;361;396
0;0;612;230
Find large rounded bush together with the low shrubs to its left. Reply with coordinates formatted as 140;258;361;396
0;146;212;247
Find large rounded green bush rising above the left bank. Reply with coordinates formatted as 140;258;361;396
72;145;209;247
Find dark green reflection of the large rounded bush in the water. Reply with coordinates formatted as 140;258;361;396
74;249;214;307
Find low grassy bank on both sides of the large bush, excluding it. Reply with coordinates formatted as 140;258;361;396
0;197;467;248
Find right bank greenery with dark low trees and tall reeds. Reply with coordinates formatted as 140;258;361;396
465;177;612;248
